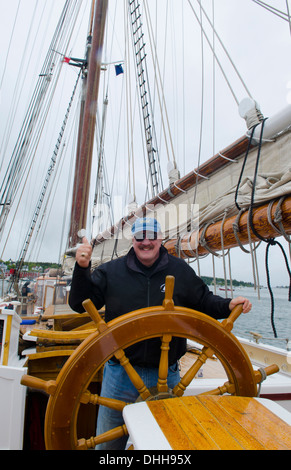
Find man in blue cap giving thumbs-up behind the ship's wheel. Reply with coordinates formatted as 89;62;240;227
69;218;252;450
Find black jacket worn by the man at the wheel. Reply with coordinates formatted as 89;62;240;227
69;247;230;367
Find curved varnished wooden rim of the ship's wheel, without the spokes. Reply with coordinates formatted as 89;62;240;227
45;307;257;449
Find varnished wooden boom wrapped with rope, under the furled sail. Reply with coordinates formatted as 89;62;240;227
164;196;291;258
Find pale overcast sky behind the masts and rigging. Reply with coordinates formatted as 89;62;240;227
0;0;291;285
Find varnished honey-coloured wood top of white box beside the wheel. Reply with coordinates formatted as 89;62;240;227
147;396;291;450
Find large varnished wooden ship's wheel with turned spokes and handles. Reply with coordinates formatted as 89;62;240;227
22;276;278;450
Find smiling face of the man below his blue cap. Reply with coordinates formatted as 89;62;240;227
133;232;162;267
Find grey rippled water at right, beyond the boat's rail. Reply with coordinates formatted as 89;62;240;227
218;287;291;349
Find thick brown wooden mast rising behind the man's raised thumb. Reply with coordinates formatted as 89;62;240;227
69;0;108;248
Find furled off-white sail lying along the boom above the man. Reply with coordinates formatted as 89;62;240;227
64;106;291;273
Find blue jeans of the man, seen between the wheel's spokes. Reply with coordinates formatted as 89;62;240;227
96;360;180;450
